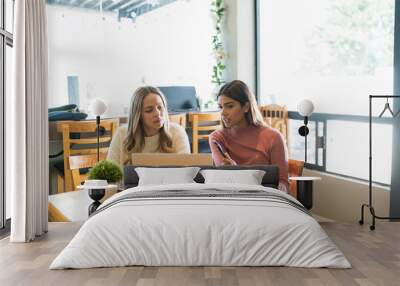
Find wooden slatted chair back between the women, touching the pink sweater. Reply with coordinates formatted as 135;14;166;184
189;112;221;154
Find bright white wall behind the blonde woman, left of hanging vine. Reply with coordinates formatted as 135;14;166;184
47;0;213;115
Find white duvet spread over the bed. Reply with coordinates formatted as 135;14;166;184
50;183;351;269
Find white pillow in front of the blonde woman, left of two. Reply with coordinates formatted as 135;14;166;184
135;167;200;186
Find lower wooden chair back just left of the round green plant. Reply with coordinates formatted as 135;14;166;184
69;152;107;190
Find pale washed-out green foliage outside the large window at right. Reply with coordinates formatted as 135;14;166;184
301;0;395;75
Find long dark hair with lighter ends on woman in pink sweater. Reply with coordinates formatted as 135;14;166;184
217;80;267;128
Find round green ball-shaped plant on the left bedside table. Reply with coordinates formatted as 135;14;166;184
88;160;122;183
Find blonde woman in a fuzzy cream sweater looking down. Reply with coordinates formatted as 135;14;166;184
107;86;190;166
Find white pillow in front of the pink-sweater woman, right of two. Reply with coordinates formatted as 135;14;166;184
200;170;265;185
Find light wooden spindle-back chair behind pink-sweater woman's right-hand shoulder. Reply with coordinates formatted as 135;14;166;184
260;104;289;144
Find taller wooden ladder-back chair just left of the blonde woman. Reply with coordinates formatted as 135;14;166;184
57;119;118;192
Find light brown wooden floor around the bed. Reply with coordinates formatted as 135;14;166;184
0;222;400;286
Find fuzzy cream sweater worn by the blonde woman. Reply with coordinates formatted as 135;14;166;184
107;122;190;167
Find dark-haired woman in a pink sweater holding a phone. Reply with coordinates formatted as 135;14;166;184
209;80;289;192
